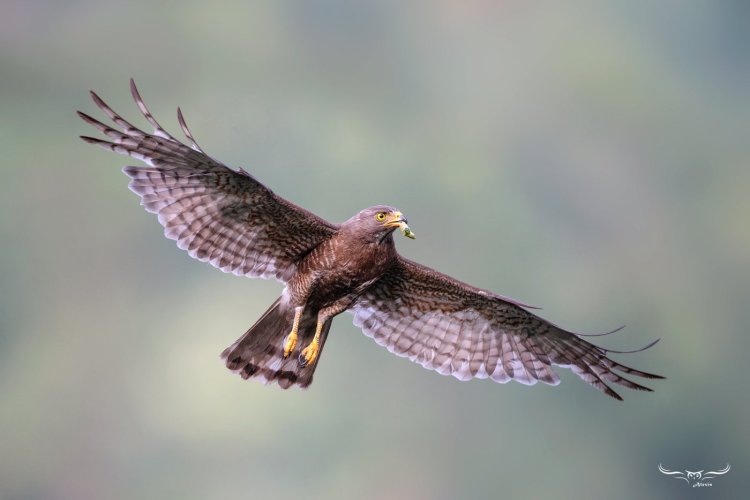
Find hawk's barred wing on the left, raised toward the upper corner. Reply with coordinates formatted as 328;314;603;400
78;80;337;282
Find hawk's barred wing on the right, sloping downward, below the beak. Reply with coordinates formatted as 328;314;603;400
351;258;663;400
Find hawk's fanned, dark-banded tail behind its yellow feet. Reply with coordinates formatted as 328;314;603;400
221;297;331;389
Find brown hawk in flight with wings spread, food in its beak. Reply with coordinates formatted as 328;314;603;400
78;79;663;400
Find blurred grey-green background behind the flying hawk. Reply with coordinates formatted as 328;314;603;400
0;0;750;499
